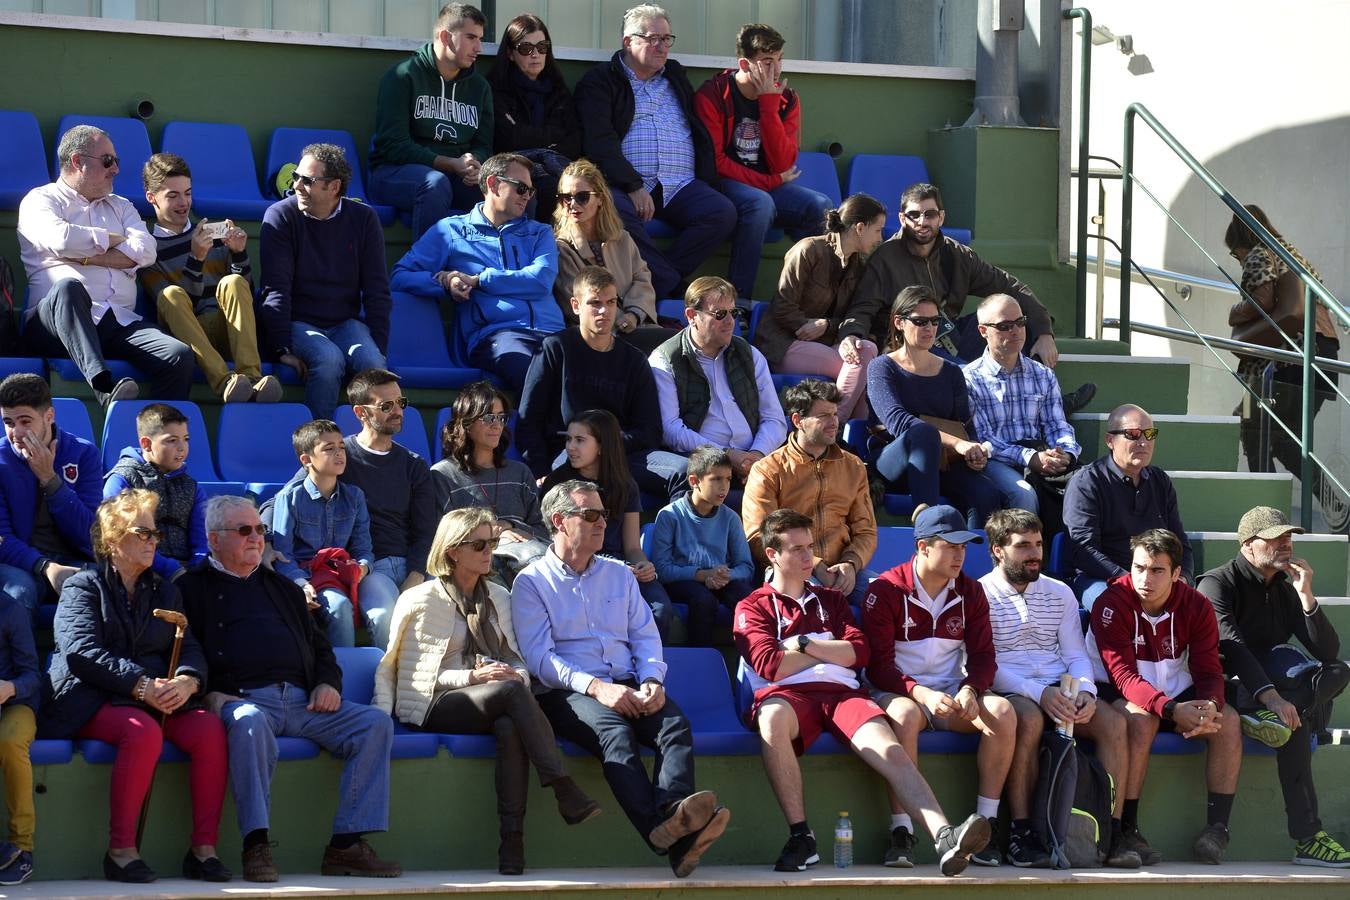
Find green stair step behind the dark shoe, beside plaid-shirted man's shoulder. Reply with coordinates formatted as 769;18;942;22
1054;354;1191;416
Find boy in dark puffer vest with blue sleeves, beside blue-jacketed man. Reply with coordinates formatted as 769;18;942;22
103;403;208;579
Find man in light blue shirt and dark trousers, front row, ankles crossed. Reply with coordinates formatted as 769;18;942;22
512;480;732;878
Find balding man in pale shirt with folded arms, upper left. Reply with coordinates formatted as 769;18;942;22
19;125;193;406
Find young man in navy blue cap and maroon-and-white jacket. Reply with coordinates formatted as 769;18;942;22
863;506;1017;866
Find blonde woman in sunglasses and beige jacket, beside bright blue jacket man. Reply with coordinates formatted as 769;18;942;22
554;159;675;354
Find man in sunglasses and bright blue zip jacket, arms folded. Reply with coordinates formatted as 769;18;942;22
390;154;563;393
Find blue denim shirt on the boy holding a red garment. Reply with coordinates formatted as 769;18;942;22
271;475;374;582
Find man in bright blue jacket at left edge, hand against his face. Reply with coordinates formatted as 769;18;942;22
0;372;103;614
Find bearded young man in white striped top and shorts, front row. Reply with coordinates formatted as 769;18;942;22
980;509;1141;869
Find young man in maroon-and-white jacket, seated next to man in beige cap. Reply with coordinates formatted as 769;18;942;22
1088;528;1242;865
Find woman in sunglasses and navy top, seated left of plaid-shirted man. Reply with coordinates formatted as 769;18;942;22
867;285;1002;528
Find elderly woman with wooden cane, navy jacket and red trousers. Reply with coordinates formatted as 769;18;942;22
38;490;231;884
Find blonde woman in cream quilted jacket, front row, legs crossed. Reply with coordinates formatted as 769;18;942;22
373;506;599;874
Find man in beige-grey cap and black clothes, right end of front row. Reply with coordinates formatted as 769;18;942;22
1196;506;1350;869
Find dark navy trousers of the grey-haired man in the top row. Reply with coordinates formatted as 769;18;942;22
609;178;736;300
